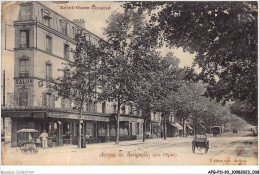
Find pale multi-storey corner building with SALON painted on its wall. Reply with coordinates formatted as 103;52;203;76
2;2;143;146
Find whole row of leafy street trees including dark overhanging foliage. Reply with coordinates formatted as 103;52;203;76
55;2;255;147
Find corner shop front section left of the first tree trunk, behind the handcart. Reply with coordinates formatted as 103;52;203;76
2;109;76;147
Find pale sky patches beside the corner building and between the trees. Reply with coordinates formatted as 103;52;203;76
1;1;195;97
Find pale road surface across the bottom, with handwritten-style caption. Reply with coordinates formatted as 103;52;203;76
1;133;258;165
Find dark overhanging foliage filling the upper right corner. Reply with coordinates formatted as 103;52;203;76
124;1;257;124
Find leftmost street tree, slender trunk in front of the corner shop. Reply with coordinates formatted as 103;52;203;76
54;35;103;148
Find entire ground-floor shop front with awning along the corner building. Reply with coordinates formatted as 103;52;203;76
2;107;143;147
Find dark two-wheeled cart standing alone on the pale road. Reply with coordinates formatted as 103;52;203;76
192;134;209;154
